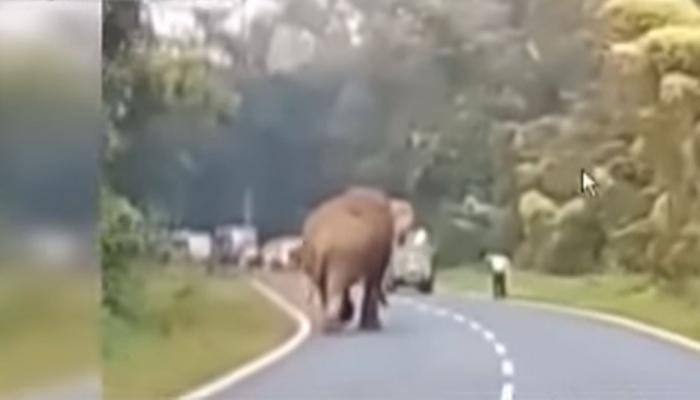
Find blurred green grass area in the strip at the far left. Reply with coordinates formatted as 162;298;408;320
0;267;99;395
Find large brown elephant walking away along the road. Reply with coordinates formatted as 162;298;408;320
293;188;394;331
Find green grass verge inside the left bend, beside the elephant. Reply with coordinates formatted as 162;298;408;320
103;269;294;400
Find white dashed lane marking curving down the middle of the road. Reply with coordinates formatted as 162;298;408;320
399;297;515;400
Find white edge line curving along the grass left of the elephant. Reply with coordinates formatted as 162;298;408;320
179;279;311;400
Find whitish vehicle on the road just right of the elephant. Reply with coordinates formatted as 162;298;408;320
386;228;435;294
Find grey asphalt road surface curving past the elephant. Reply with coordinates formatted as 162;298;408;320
213;295;700;400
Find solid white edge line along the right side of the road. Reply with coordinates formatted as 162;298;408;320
508;300;700;353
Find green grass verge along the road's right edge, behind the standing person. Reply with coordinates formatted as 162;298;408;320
438;267;700;340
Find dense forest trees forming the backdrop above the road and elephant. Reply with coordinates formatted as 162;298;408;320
100;0;698;282
